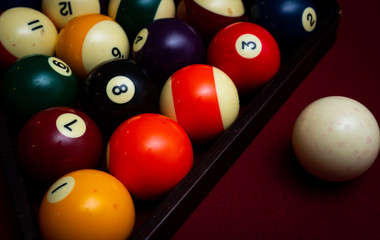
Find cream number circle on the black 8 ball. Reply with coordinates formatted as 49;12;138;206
106;76;135;104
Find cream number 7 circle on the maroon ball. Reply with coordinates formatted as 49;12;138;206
56;113;86;138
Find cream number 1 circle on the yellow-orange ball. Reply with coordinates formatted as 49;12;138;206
46;176;75;203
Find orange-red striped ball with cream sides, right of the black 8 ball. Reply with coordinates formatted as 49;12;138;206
160;64;240;144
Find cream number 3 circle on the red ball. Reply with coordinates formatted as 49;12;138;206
235;34;263;59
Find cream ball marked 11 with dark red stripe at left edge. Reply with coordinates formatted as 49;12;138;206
0;7;58;68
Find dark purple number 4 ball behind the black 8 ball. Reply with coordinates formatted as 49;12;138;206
132;18;206;86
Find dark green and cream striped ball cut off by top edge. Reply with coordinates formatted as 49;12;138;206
108;0;176;42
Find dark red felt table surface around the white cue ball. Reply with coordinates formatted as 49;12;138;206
173;0;380;239
